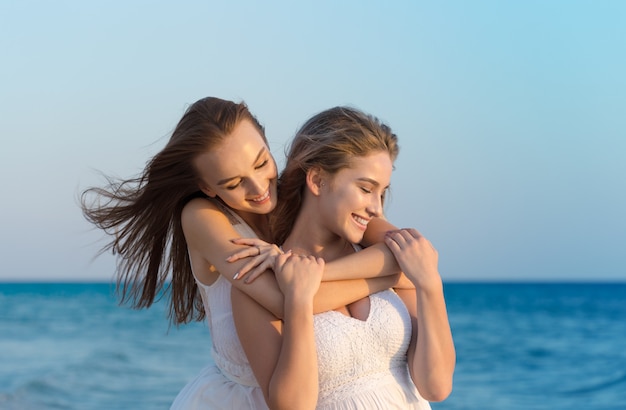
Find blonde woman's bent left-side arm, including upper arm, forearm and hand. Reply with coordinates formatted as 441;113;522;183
232;255;324;409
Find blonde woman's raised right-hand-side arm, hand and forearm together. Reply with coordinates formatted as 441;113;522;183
387;230;456;401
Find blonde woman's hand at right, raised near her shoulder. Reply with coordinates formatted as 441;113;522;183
385;229;441;290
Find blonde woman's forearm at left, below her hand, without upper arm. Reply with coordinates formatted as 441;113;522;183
268;301;318;409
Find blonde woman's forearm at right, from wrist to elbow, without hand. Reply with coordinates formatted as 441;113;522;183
409;287;456;401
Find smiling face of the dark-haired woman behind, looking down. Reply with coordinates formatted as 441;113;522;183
194;120;277;214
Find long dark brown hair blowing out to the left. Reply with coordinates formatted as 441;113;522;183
80;97;265;325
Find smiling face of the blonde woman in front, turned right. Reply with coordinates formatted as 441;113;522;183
319;151;393;243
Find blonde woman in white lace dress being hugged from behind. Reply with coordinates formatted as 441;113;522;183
233;107;455;409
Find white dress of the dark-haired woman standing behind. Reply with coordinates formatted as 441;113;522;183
171;208;268;410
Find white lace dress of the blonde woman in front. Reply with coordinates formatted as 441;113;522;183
314;290;430;410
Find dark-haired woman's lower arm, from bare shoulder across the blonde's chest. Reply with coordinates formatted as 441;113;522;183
182;198;397;318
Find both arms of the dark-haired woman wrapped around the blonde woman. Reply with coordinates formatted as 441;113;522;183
182;198;400;318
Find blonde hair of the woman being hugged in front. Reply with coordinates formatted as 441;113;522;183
271;107;399;244
